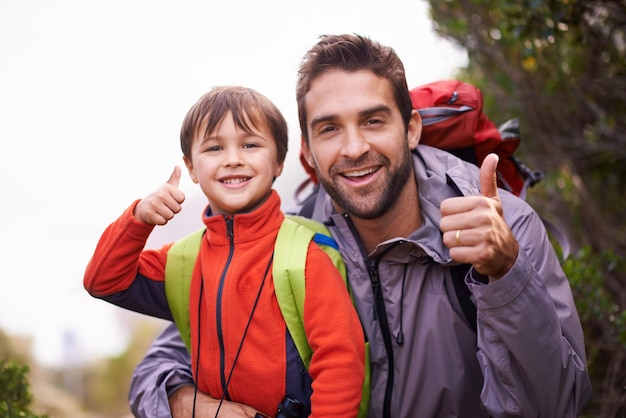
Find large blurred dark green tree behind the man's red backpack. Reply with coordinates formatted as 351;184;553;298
418;0;626;417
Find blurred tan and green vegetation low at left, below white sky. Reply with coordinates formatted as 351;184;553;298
0;324;163;418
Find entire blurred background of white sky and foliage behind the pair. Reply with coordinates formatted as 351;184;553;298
0;0;626;418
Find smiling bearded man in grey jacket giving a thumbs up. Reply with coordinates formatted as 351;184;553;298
131;35;591;418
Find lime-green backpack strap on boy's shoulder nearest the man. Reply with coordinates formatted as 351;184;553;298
272;215;370;417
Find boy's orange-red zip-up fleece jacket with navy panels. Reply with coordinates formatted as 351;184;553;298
84;191;364;417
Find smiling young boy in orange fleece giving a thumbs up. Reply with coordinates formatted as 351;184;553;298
84;87;364;417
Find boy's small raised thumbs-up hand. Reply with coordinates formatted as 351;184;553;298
133;166;185;225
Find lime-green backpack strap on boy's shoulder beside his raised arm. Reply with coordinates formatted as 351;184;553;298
165;228;205;352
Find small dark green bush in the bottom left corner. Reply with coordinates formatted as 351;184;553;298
0;360;47;418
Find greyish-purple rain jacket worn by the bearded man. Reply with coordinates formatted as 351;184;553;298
130;145;591;418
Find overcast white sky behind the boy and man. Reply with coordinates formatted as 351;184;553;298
0;0;466;365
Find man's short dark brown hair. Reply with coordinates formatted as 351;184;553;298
296;34;413;143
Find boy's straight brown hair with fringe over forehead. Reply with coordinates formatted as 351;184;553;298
180;86;289;164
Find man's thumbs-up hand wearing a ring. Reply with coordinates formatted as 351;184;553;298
439;154;519;281
